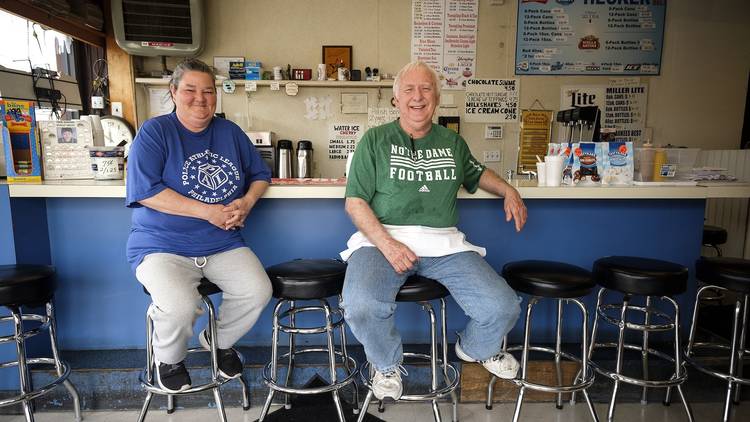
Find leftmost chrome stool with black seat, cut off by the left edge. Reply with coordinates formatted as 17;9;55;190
0;264;81;421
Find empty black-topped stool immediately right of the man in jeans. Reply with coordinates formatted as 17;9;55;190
496;260;599;422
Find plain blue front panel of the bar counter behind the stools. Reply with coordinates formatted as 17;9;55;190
0;190;705;353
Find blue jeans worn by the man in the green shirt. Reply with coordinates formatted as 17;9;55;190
340;247;520;372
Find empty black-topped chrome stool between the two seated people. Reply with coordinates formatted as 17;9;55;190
258;259;359;422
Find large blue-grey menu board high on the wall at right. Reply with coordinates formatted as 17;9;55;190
516;0;667;75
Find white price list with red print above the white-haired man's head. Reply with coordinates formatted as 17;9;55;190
411;0;479;89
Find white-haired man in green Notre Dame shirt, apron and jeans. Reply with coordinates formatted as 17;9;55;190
341;62;526;400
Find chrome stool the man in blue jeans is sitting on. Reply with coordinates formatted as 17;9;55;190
358;275;460;422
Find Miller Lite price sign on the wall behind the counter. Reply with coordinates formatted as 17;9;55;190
560;84;648;143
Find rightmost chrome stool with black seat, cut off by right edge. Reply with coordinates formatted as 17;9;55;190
685;257;750;421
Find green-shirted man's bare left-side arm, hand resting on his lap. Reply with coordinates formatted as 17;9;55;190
345;197;417;273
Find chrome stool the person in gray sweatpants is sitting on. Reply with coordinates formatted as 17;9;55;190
138;278;250;422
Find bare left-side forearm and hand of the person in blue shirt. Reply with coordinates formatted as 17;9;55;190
138;188;230;229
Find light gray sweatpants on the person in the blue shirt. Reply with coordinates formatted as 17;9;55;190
135;247;272;363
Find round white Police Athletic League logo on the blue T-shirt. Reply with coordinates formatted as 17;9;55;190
181;150;240;204
